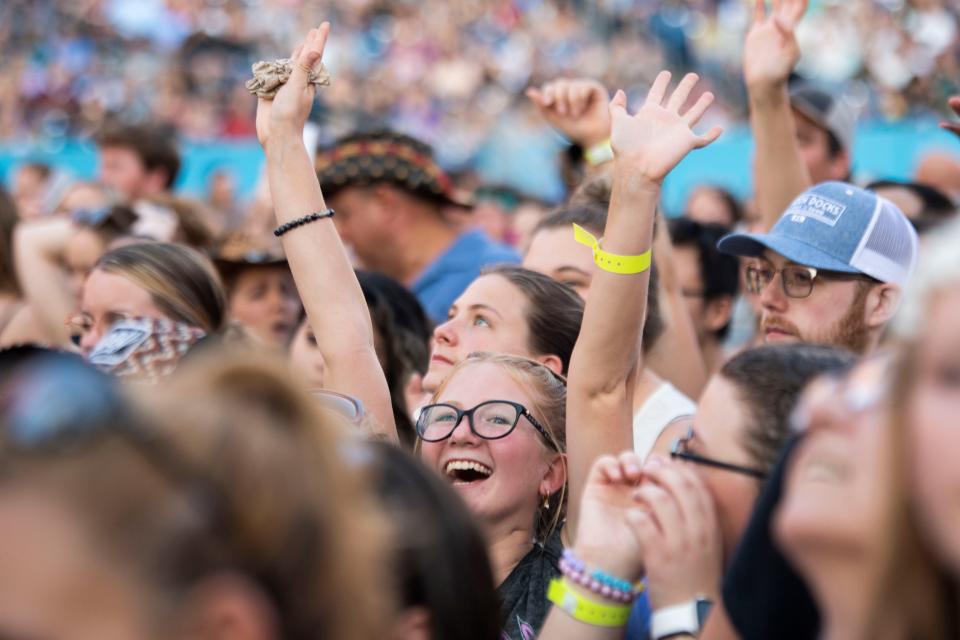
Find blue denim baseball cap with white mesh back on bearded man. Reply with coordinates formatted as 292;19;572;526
717;182;918;287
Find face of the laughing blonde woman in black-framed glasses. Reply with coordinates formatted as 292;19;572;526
421;362;566;537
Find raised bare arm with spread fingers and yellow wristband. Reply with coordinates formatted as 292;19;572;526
567;71;720;531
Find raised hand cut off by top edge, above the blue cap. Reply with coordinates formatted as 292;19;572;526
743;0;809;90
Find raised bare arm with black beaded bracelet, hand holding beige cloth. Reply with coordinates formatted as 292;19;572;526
257;22;397;441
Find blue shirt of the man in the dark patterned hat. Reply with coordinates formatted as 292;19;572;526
411;230;520;324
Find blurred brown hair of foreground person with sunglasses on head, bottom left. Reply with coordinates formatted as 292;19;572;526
0;353;390;640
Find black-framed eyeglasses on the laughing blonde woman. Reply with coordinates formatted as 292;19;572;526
417;400;555;448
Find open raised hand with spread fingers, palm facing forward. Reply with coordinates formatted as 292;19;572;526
610;71;723;183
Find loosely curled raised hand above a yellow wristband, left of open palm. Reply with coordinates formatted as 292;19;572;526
527;78;610;147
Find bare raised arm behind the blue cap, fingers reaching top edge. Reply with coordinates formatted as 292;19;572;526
743;0;811;231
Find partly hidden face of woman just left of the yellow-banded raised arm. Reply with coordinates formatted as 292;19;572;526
523;227;597;300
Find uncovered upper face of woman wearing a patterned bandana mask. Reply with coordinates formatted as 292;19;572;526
80;269;170;357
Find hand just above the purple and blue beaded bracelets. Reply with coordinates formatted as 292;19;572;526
574;451;643;582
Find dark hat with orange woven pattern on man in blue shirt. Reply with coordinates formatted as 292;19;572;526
316;130;473;207
